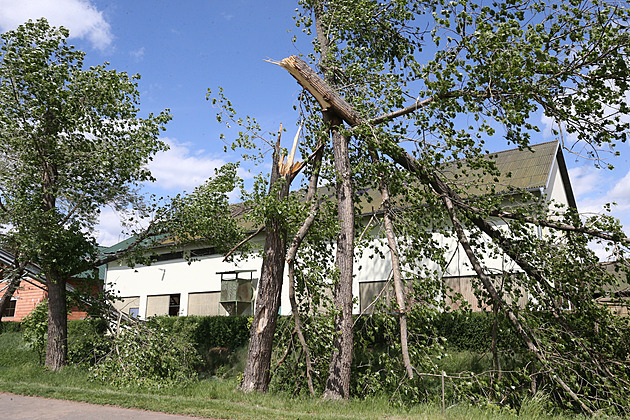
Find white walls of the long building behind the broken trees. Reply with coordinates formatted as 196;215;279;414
106;148;569;318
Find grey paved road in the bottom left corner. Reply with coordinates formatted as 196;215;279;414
0;393;202;420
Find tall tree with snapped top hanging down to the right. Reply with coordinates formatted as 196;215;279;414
215;0;630;413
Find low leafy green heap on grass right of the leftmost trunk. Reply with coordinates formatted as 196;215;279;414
90;322;199;388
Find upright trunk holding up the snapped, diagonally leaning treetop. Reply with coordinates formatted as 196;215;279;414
324;113;354;399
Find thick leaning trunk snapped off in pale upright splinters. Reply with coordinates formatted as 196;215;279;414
240;136;289;392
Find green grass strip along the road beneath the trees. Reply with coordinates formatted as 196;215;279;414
0;332;596;420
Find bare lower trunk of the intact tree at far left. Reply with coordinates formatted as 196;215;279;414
45;270;68;370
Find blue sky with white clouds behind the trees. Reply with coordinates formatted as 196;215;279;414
0;0;630;256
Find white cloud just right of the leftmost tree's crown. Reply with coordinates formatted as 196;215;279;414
149;138;226;192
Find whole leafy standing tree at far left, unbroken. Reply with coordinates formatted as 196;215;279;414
0;19;170;370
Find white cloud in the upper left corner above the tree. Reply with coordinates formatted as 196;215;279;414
0;0;113;50
